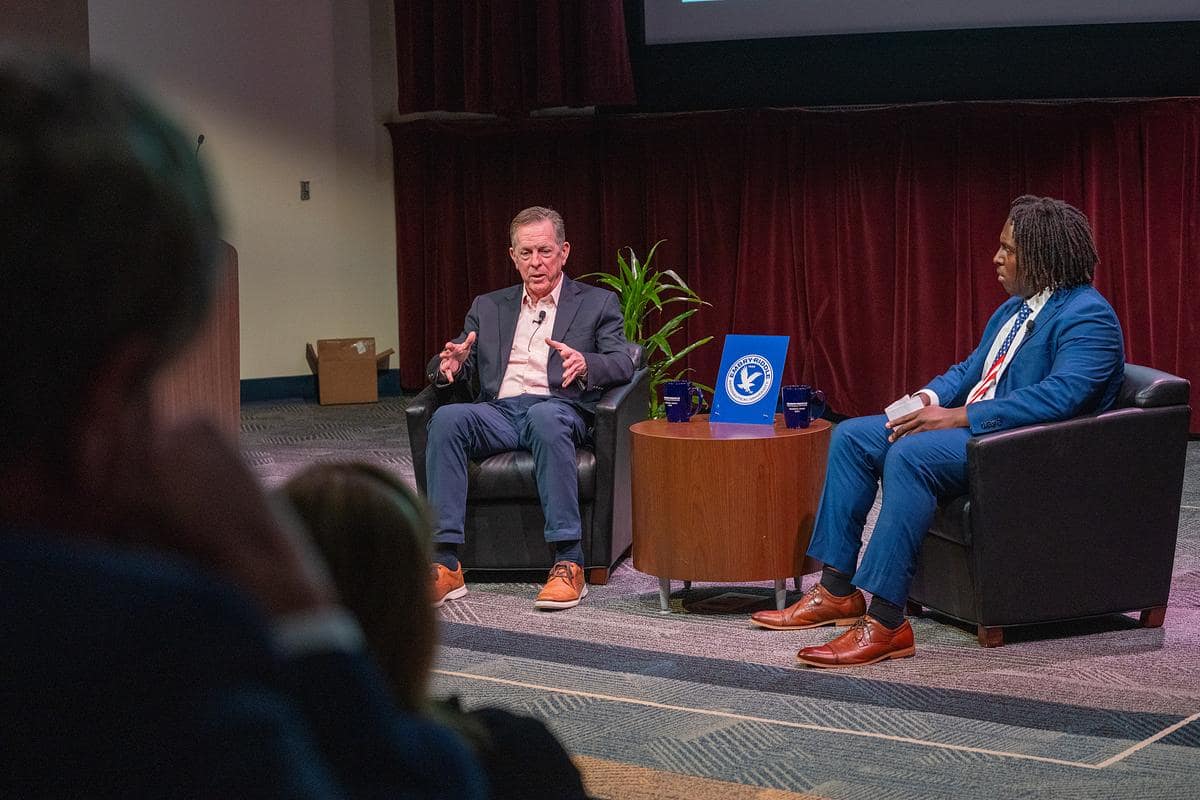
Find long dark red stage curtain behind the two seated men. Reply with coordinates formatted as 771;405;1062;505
391;104;1200;431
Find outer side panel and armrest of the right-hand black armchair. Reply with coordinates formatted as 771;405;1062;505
967;405;1189;624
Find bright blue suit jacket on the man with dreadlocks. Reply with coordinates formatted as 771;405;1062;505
926;285;1124;434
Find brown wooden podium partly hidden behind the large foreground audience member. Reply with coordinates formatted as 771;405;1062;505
155;242;241;440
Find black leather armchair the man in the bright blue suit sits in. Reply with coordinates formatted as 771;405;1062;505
908;363;1190;646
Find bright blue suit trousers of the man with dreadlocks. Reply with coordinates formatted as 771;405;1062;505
809;414;971;606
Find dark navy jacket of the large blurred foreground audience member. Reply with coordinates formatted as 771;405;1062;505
0;527;484;799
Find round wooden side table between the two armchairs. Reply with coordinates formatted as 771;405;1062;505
630;414;830;613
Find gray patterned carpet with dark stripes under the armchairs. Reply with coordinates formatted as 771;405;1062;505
242;398;1200;800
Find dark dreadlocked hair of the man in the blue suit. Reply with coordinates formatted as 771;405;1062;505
1008;194;1099;293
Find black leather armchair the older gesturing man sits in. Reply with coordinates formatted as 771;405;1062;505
406;344;650;584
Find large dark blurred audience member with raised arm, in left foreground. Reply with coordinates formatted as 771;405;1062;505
0;55;486;800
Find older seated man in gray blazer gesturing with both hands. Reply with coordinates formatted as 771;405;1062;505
425;206;634;610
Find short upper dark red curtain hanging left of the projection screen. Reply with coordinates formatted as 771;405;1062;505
395;0;635;114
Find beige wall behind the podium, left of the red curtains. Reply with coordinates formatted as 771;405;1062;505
89;0;397;378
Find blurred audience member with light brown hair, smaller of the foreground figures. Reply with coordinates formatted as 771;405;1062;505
282;463;586;800
